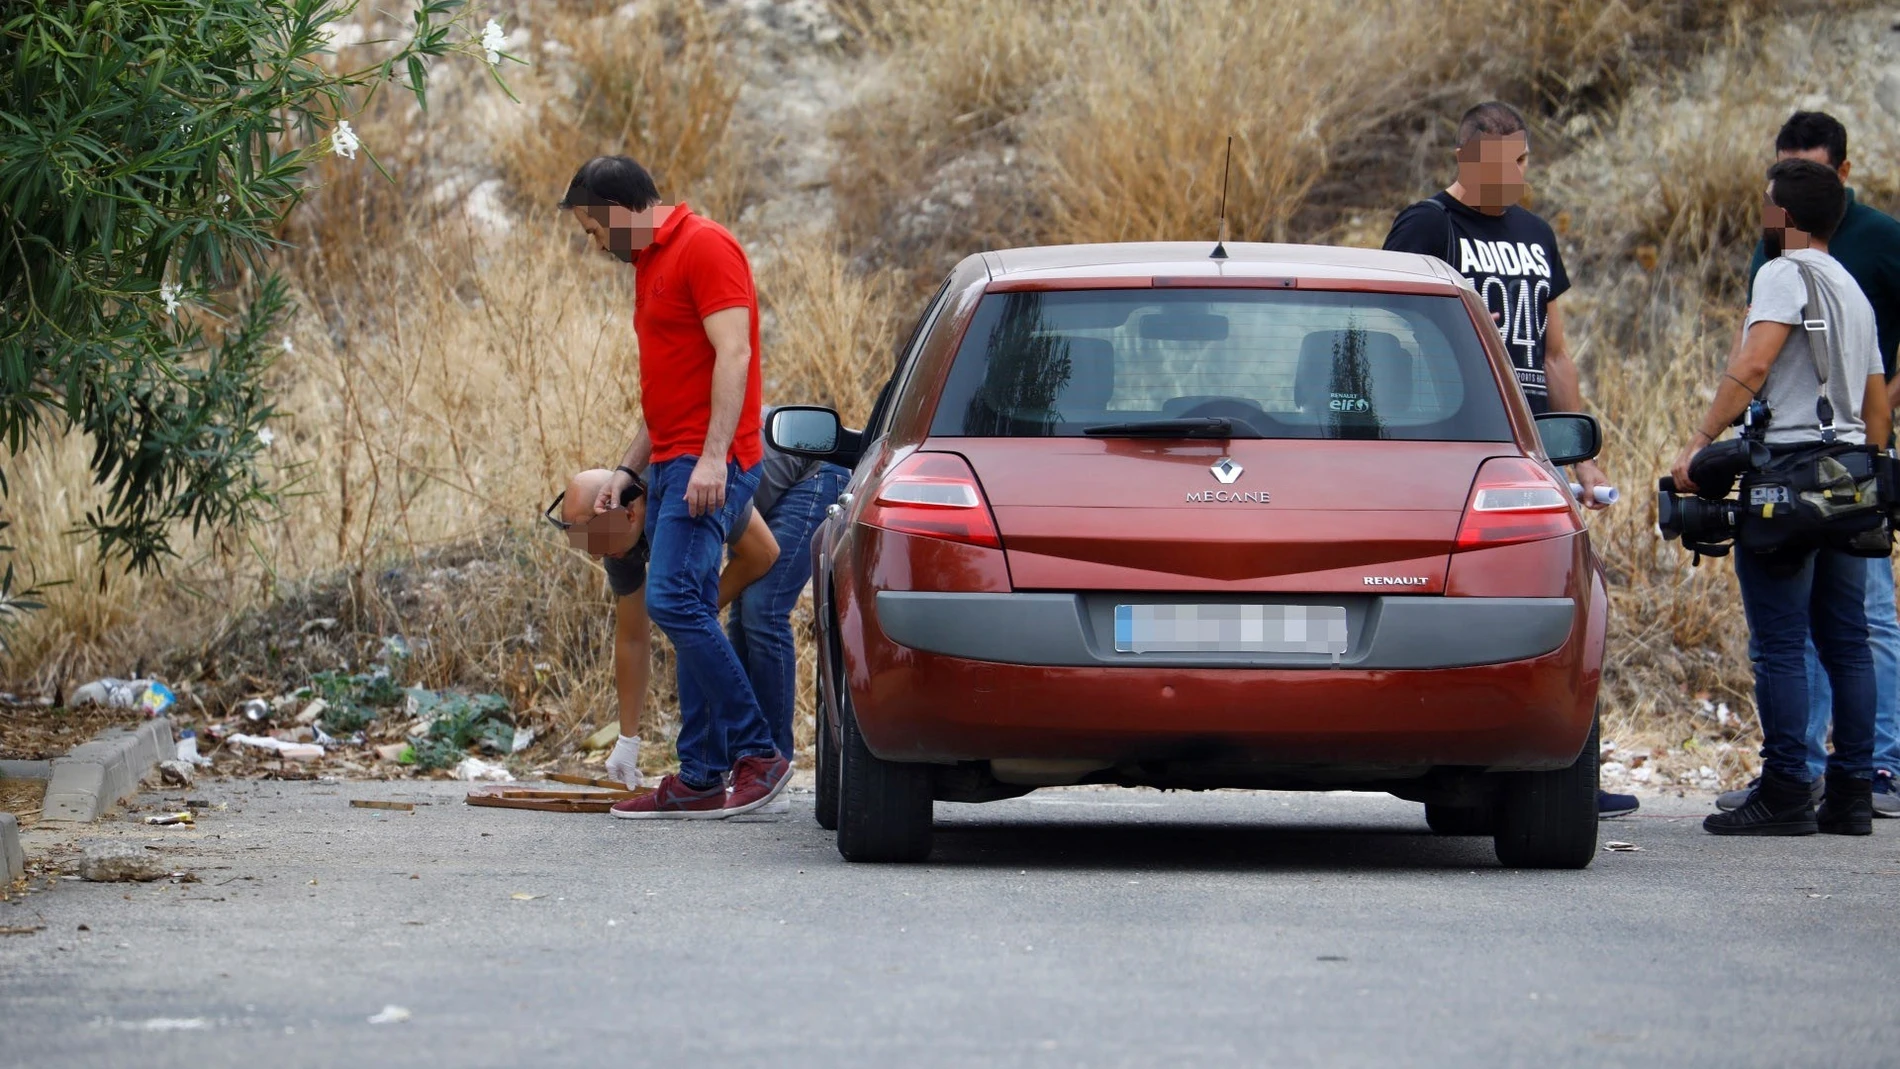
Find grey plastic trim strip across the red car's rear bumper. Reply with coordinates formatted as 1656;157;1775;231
878;591;1577;670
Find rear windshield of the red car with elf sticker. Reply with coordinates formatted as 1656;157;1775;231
931;289;1511;442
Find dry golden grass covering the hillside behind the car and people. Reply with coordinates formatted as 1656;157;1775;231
0;0;1900;780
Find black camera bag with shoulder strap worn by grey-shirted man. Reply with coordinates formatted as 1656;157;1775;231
1737;260;1900;556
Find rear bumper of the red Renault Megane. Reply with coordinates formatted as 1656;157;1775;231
847;591;1602;775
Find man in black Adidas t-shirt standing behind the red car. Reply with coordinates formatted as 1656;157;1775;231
1385;101;1638;816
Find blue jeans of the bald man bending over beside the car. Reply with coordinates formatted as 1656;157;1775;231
726;463;851;756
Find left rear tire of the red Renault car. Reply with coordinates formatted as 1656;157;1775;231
838;687;933;862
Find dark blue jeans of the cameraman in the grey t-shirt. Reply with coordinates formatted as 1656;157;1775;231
1735;549;1875;782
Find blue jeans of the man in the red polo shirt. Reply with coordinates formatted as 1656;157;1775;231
646;456;773;790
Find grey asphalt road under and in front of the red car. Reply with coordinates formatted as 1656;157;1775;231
0;782;1900;1069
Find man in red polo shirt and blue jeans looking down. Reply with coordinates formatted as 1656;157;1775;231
561;156;792;820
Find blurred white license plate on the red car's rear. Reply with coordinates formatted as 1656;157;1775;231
1115;606;1347;655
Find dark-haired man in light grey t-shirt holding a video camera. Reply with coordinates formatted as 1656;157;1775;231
1672;159;1892;835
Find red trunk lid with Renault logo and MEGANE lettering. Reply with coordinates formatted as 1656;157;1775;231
942;437;1514;594
